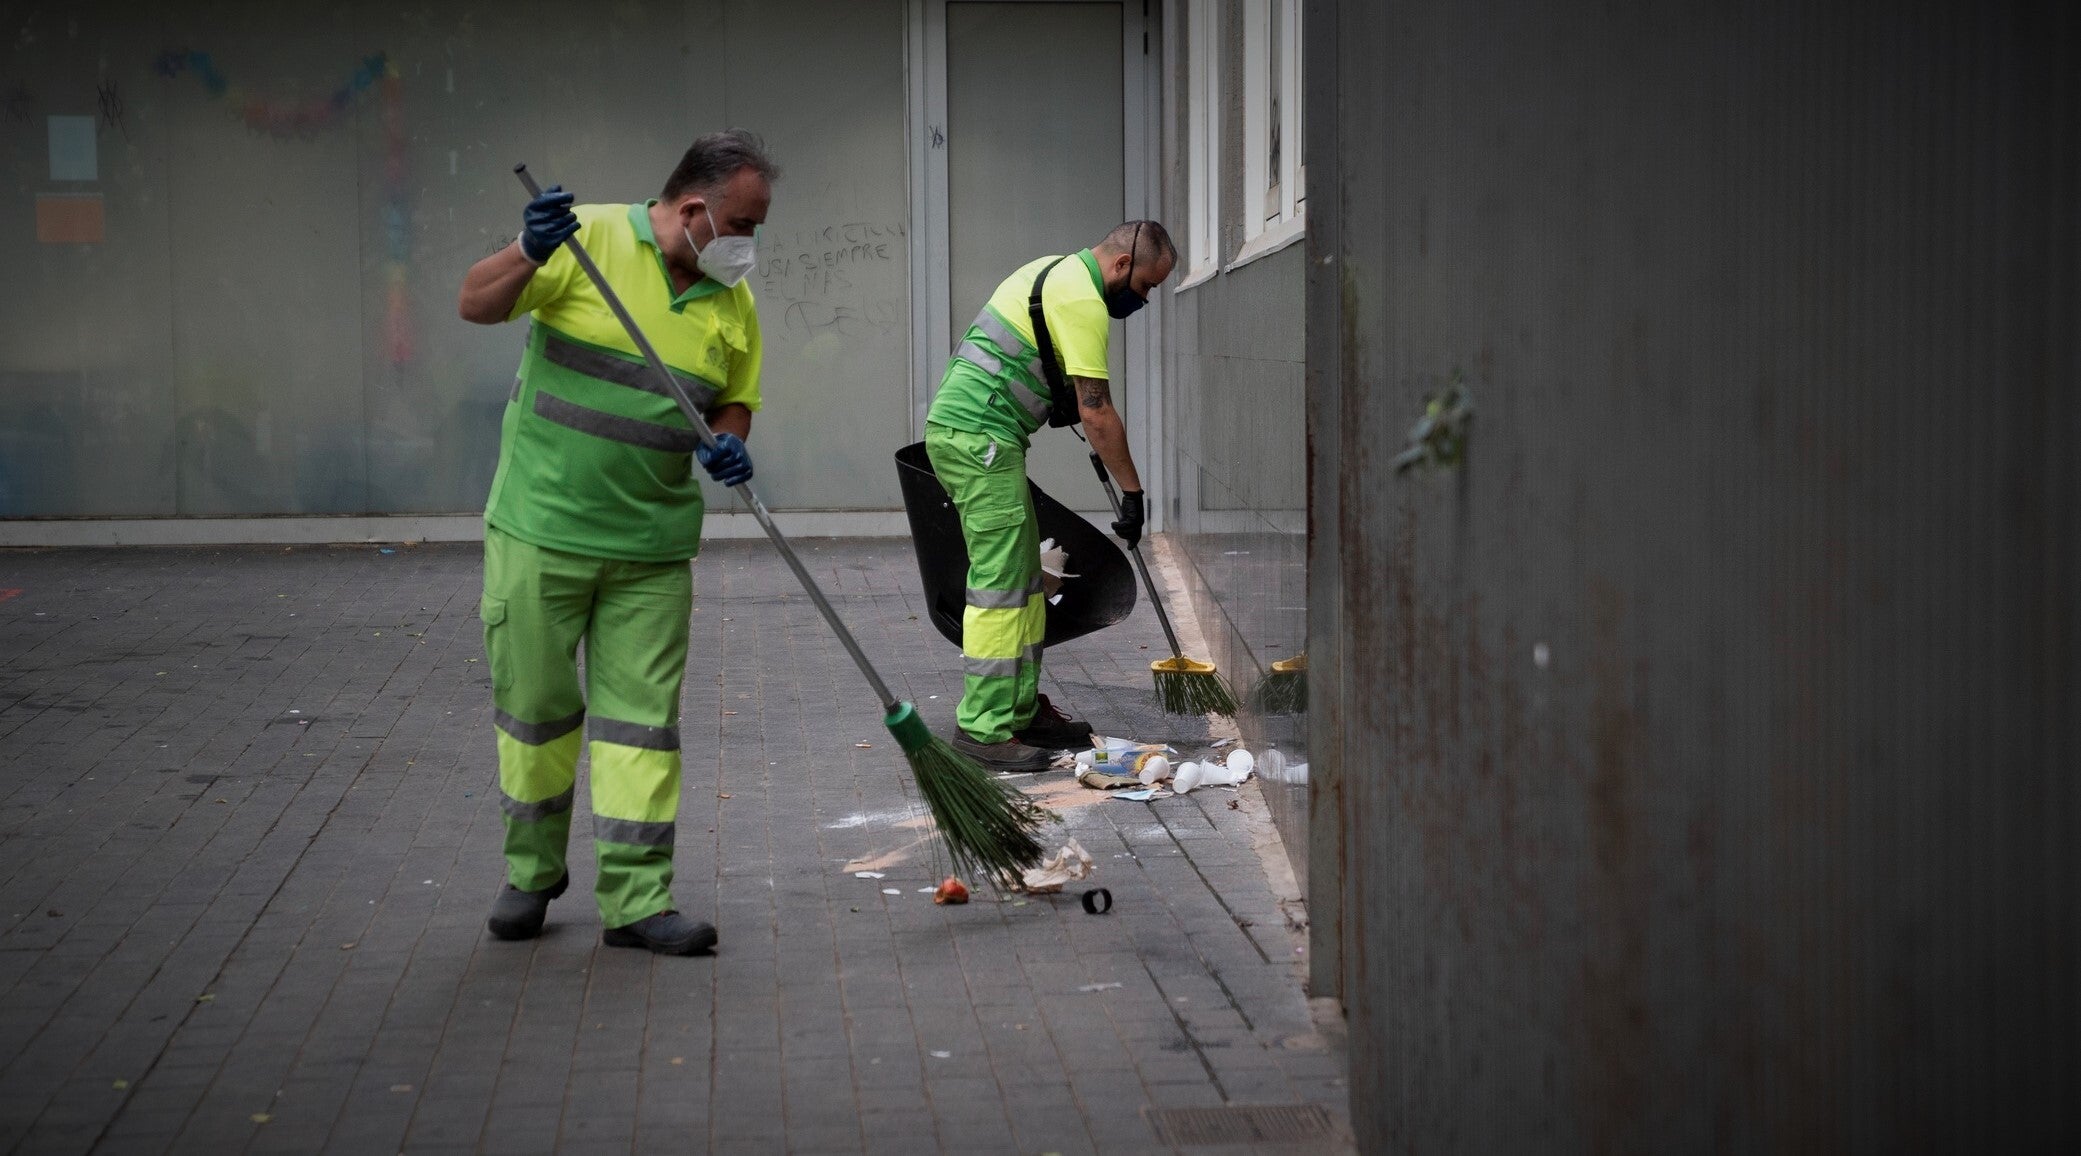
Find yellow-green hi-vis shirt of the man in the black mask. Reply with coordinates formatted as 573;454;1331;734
926;249;1113;447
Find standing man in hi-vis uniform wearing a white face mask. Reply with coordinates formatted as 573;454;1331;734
460;129;778;954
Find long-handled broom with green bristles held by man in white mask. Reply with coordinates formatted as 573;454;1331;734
514;164;1055;884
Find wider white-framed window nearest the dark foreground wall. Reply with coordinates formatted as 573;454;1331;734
1234;0;1307;264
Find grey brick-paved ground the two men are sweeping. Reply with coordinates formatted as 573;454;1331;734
0;541;1344;1154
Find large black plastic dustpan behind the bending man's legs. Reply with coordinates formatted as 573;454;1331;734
897;441;1134;647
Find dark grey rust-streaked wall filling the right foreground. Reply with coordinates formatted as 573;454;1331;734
1307;0;2081;1152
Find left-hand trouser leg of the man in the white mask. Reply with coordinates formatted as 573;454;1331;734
479;526;597;892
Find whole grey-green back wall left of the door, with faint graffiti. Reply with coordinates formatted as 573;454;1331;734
0;0;909;518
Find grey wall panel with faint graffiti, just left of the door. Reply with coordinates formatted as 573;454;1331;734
740;0;911;509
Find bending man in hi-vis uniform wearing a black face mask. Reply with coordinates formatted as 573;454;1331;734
924;220;1178;771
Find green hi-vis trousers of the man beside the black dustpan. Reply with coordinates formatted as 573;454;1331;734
926;424;1047;742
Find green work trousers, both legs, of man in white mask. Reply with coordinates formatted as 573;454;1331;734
481;526;693;927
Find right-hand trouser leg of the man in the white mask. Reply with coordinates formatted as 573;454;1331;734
585;561;693;927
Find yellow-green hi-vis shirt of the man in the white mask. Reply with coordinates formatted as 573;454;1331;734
485;202;760;561
